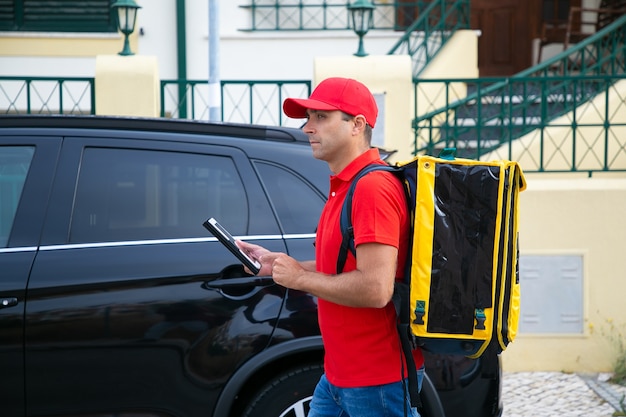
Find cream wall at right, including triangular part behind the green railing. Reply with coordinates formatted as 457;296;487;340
486;80;626;372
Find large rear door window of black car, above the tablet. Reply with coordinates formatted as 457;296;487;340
70;148;248;243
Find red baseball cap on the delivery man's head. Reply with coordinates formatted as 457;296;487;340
283;77;378;127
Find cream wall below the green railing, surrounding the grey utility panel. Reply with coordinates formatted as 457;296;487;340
502;174;626;372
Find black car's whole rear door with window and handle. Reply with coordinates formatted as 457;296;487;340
24;134;285;417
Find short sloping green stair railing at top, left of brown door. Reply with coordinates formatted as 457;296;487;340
389;0;470;79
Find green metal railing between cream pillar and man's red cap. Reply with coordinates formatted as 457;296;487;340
161;80;311;127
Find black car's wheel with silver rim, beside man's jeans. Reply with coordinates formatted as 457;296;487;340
243;365;324;417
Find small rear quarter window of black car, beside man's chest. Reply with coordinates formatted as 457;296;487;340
256;161;324;234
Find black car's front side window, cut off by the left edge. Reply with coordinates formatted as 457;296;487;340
0;146;35;248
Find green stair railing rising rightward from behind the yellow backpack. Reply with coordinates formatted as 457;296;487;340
413;15;626;163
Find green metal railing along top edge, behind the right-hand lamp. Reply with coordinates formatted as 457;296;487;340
240;0;434;31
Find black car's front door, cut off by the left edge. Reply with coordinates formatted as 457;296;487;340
0;133;61;417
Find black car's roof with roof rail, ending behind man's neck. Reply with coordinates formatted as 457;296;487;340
0;115;331;195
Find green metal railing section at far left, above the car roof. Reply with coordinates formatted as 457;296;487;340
0;76;96;114
